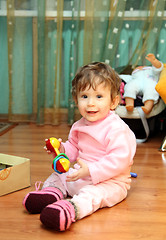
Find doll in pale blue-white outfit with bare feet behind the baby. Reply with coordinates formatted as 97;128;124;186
120;53;163;114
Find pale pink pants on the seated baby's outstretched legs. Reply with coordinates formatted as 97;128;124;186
43;168;130;219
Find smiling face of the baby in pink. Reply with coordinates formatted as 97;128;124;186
77;83;112;122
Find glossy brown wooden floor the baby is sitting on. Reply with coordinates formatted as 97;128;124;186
0;124;166;240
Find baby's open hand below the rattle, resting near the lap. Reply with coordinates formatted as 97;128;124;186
66;158;90;182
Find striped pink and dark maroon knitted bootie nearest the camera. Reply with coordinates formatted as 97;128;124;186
40;200;75;231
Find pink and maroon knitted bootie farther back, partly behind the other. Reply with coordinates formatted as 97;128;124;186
23;187;63;213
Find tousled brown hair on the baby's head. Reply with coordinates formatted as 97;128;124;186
72;62;121;101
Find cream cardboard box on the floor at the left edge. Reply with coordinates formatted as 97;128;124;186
0;153;31;196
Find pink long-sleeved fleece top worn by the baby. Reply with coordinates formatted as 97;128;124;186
63;111;136;184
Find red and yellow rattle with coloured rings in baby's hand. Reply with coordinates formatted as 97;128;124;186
46;137;70;174
